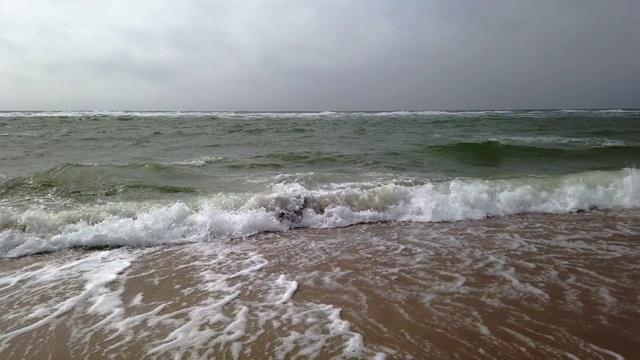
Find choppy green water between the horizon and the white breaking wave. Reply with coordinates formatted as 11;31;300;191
0;111;640;198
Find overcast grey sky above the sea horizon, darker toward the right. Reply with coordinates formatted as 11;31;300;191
0;0;640;111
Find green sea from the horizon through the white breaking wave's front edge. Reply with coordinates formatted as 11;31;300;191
0;110;640;256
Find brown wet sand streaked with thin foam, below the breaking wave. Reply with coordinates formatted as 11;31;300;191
0;211;640;359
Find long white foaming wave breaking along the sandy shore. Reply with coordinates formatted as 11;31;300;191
0;169;640;257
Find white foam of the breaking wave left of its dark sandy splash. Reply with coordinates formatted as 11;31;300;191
0;203;286;257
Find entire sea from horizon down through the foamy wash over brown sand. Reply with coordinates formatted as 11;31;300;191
0;109;640;359
